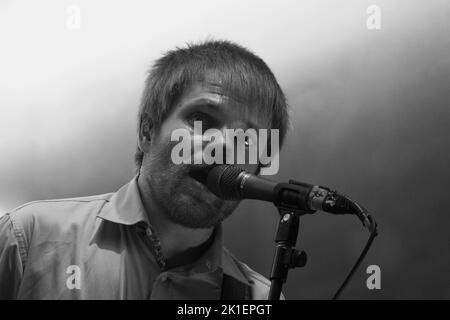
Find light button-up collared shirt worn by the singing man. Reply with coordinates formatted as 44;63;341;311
0;178;270;299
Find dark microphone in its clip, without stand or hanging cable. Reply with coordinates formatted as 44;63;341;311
200;165;358;214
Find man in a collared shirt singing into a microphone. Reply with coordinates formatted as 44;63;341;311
0;41;288;299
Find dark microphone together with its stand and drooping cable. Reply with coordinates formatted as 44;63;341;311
195;165;378;299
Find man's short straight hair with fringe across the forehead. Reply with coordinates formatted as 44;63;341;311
135;40;289;170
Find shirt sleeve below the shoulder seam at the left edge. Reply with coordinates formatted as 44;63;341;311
0;214;23;299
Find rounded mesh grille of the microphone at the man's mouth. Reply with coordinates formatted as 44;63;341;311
207;165;245;200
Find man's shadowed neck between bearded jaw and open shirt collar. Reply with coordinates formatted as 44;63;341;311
138;176;214;268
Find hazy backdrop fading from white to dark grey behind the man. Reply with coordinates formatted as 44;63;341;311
0;0;450;299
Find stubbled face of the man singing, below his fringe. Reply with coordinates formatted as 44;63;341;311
141;82;269;228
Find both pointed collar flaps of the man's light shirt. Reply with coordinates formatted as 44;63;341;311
97;176;251;285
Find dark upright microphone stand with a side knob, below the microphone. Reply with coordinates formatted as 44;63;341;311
269;206;308;300
